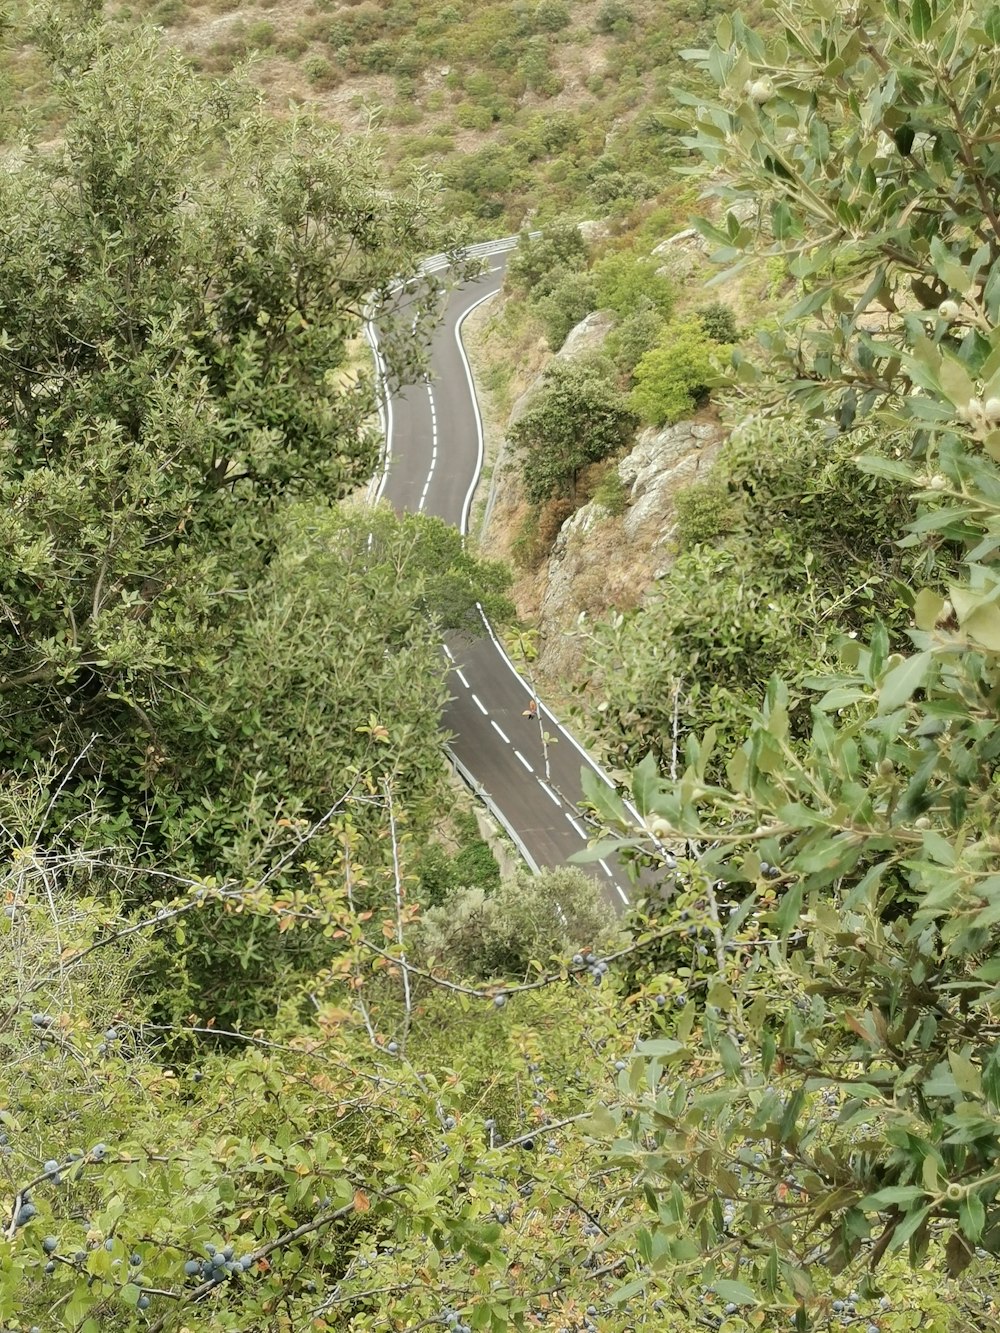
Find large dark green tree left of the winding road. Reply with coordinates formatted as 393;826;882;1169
0;16;445;810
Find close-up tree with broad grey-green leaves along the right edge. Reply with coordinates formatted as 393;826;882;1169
578;0;1000;1311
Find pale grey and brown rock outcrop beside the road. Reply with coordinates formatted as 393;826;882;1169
536;420;723;684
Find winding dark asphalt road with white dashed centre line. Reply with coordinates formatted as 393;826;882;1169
376;243;629;910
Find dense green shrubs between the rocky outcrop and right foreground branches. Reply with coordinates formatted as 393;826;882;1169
588;416;912;776
